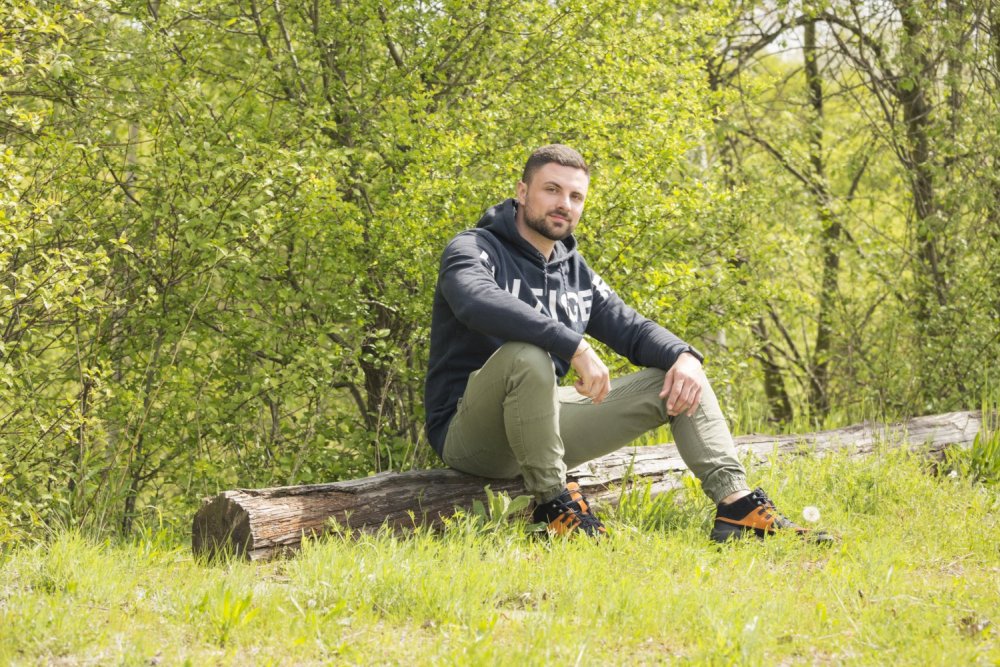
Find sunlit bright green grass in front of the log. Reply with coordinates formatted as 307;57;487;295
0;452;1000;665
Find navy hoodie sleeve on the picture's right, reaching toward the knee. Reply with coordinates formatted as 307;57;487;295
587;267;704;370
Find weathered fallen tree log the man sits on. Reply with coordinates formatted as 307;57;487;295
192;411;982;560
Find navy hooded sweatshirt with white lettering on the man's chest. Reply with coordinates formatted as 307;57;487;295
424;199;701;455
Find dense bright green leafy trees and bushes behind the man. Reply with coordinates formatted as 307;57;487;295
0;0;1000;541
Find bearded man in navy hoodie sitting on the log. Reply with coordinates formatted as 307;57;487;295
425;144;824;542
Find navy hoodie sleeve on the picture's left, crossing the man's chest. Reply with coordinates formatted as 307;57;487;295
438;233;583;360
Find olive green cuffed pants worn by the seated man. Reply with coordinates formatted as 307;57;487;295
444;343;747;502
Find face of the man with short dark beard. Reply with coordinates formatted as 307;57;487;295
517;162;590;241
